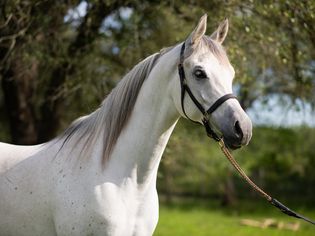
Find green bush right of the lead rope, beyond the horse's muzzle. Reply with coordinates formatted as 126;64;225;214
237;127;315;200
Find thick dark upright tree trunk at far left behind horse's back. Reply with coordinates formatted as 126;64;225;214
0;1;64;144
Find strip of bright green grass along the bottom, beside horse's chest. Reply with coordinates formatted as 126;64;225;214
154;199;315;236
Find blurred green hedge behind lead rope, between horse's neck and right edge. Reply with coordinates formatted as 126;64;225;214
158;121;315;202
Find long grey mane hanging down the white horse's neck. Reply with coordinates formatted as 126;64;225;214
58;50;164;164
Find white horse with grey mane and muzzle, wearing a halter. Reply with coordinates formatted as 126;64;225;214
0;16;252;236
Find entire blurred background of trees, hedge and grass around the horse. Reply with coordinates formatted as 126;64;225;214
0;0;315;235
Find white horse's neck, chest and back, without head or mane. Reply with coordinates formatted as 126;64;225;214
0;43;178;235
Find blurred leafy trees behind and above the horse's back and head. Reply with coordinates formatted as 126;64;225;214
0;0;315;144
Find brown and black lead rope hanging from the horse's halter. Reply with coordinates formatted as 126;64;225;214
218;138;315;225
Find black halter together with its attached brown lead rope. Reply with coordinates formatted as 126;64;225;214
178;42;315;225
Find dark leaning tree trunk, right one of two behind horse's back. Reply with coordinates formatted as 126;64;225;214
38;1;124;142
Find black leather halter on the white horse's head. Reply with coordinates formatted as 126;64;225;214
178;42;237;141
